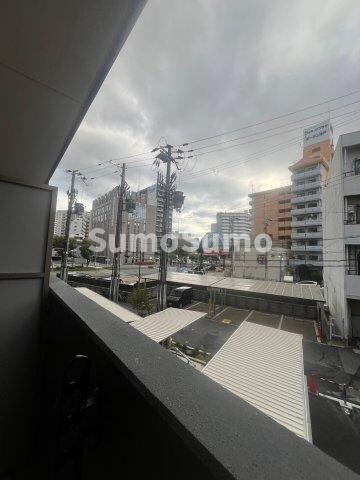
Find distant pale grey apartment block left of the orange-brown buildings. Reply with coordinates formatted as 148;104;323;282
211;210;251;252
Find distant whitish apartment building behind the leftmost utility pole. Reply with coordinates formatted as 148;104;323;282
54;203;90;240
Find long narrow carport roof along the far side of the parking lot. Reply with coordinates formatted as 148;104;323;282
144;272;325;302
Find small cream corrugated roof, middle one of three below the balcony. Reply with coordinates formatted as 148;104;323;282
131;308;206;342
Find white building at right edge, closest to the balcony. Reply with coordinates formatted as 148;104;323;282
323;131;360;343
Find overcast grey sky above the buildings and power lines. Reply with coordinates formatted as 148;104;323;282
51;0;360;234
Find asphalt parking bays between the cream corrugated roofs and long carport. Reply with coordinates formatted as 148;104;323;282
173;302;316;360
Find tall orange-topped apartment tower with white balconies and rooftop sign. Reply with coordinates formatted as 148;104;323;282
289;121;333;281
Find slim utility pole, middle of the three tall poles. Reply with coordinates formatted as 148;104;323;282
109;163;126;303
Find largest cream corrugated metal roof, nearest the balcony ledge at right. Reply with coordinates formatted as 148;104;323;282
203;321;311;441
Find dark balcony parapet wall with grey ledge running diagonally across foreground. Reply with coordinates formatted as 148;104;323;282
38;280;357;480
